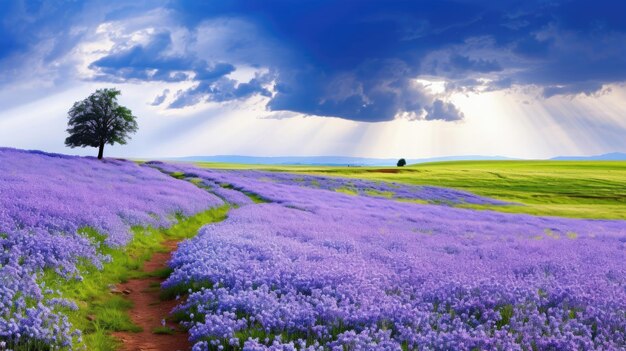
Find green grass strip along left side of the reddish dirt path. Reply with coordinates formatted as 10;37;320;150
37;206;229;351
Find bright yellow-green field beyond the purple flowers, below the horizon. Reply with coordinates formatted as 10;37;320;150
198;161;626;219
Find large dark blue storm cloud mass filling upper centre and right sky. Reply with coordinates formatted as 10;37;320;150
163;0;626;121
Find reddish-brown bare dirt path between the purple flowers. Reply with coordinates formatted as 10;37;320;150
113;241;191;351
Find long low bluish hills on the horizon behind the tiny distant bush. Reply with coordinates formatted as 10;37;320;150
171;155;512;166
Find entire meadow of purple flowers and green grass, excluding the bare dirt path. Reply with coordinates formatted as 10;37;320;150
0;149;626;351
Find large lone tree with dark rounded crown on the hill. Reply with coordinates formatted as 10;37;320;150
65;89;137;159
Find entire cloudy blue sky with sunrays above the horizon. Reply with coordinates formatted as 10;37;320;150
0;0;626;158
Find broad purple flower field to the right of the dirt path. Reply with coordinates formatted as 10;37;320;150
161;165;626;351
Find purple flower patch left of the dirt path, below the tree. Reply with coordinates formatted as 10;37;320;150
0;148;222;348
